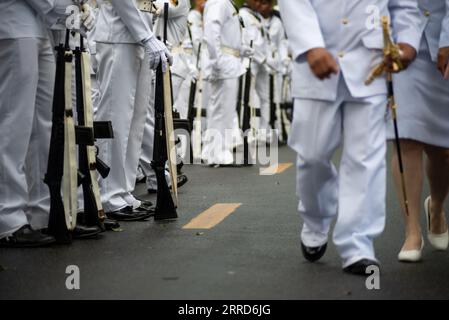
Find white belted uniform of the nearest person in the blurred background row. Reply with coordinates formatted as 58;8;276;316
201;0;245;164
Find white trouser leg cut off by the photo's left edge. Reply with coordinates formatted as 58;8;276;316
0;38;40;238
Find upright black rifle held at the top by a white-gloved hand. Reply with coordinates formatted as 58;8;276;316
151;3;178;220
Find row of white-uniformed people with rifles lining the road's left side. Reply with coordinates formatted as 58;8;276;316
0;0;291;247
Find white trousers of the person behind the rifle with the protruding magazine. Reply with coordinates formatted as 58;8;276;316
96;42;151;212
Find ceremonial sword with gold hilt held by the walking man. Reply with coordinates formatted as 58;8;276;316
365;16;409;216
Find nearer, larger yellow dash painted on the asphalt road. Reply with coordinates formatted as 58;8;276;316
182;203;242;229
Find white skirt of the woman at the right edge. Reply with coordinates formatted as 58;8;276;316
387;38;449;148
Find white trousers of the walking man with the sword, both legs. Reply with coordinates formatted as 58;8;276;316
289;78;387;267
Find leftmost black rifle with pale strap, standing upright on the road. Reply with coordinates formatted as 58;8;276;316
44;30;76;243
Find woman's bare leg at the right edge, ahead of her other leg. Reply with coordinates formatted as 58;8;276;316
424;145;449;234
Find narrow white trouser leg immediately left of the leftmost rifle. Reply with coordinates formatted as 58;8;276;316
25;40;56;229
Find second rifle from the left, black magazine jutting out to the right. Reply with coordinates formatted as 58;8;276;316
75;30;113;230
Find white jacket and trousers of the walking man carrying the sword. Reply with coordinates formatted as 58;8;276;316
279;0;421;267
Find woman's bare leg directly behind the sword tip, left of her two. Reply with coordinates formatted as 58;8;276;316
391;139;424;250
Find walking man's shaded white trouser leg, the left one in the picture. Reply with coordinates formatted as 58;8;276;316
289;99;341;247
